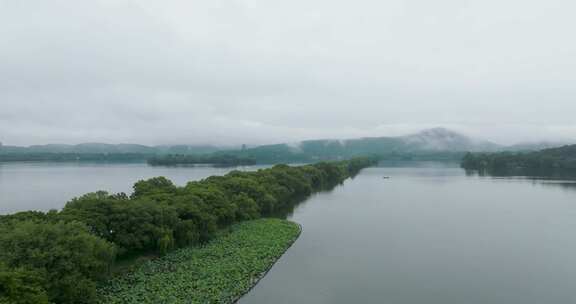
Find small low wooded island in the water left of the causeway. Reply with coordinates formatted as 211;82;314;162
148;154;256;166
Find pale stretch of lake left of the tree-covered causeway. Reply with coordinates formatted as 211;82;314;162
0;162;266;214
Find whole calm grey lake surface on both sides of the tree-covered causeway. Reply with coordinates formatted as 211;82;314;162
0;163;576;304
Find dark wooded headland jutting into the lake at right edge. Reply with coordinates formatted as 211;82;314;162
461;145;576;172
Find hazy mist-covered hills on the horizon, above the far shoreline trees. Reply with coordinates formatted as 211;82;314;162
0;128;567;163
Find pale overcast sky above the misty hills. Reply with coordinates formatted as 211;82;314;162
0;0;576;145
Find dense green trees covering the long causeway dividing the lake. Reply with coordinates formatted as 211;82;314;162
0;158;374;304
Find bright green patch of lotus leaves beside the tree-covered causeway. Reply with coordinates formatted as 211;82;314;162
99;219;300;304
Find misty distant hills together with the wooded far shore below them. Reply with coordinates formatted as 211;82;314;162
0;128;559;165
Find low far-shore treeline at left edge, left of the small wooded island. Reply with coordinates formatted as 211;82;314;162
0;152;151;162
